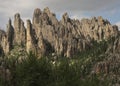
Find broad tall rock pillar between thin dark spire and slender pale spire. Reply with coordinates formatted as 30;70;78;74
14;13;26;46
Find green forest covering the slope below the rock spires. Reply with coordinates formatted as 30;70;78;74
0;41;109;86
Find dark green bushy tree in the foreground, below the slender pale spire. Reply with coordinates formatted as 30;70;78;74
11;53;52;86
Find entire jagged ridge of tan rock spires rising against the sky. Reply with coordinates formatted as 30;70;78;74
0;8;119;57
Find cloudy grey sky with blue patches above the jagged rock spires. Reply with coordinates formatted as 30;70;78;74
0;0;120;29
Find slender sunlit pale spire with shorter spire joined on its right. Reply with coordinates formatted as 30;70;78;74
26;20;46;57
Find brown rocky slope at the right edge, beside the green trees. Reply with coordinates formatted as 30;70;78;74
93;31;120;78
